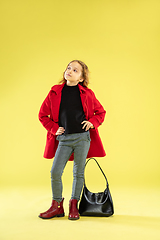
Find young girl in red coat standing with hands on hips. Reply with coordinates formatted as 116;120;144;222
39;60;106;220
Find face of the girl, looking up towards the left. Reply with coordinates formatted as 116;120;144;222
64;62;84;86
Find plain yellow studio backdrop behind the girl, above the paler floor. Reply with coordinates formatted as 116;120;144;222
0;0;160;191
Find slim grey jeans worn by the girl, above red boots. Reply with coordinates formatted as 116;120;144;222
51;131;91;202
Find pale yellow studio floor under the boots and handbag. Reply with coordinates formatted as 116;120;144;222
0;187;160;240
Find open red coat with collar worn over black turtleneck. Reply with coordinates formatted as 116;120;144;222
39;83;106;160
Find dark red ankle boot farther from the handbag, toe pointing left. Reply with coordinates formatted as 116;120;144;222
39;198;65;219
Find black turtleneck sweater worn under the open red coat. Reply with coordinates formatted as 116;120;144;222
59;84;86;134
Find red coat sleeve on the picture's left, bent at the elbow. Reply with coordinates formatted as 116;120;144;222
38;92;59;135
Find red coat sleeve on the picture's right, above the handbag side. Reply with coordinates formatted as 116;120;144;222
88;91;106;128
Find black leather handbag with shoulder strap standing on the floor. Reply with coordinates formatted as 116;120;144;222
79;158;114;217
